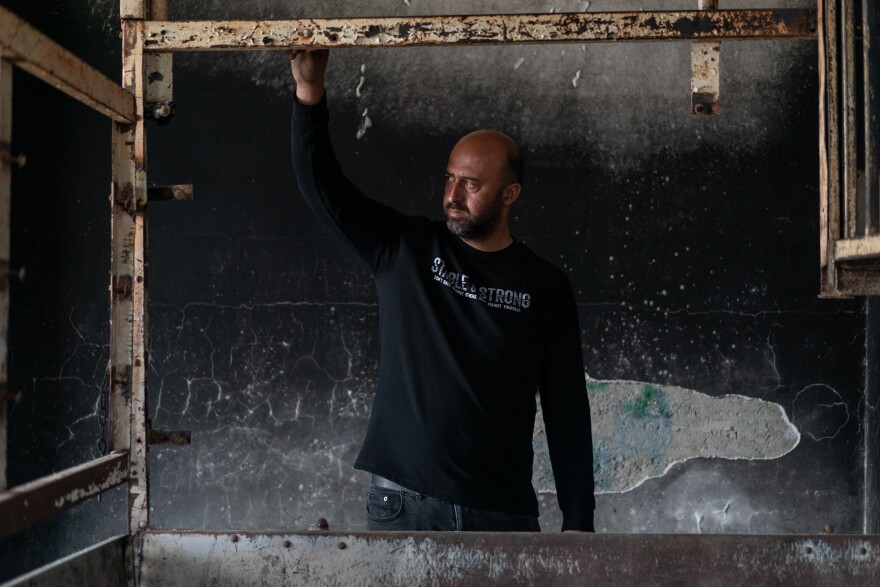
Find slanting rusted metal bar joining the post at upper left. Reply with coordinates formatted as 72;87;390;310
0;6;134;123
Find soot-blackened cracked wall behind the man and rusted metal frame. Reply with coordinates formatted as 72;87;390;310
0;0;873;578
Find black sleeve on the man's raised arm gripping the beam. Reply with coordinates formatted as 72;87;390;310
290;94;410;273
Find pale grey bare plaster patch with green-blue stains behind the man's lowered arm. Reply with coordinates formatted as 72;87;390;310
533;380;800;493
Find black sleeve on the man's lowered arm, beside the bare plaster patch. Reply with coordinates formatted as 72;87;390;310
540;276;596;532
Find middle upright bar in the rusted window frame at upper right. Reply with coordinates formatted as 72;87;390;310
844;0;859;238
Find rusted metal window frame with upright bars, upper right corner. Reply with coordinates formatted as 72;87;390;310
819;0;880;298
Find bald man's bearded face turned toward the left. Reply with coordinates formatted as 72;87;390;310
443;135;506;239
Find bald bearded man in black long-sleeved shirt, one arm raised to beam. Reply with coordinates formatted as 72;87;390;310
290;51;595;531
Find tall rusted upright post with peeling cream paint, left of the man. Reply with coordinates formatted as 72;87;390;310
110;5;149;534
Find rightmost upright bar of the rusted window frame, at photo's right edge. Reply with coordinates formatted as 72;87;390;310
858;0;880;236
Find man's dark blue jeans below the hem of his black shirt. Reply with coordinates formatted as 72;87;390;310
367;485;541;532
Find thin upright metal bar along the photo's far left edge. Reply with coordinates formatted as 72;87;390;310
0;48;12;491
